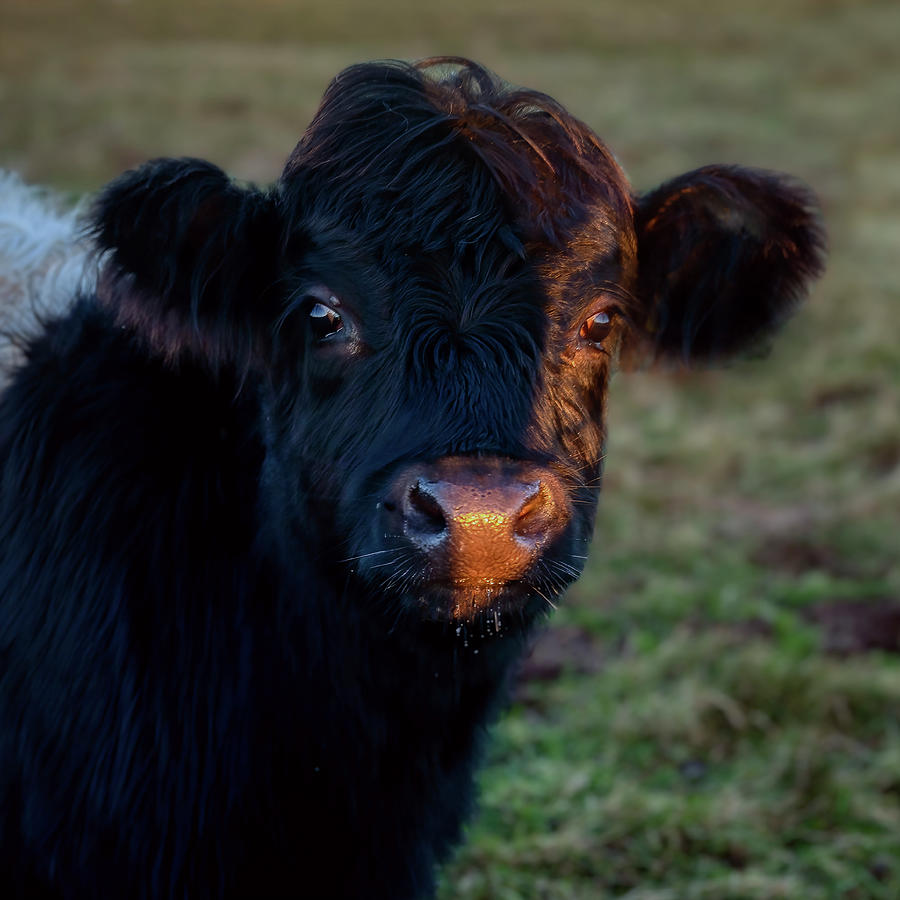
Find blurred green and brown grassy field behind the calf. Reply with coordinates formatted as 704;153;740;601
0;0;900;900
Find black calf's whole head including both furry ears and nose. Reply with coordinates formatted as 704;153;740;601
89;59;823;628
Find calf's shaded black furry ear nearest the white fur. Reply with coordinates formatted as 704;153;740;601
93;159;281;364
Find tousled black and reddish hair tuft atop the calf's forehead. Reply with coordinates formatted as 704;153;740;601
283;57;632;253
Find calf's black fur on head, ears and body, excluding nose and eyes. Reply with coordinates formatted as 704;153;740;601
0;60;821;900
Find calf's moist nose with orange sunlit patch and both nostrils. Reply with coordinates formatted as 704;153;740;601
392;457;569;584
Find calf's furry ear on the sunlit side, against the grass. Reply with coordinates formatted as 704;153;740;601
635;166;825;363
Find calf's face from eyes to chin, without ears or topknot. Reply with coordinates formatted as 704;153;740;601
267;229;617;620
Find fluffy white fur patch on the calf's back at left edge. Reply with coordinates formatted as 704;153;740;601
0;169;97;386
